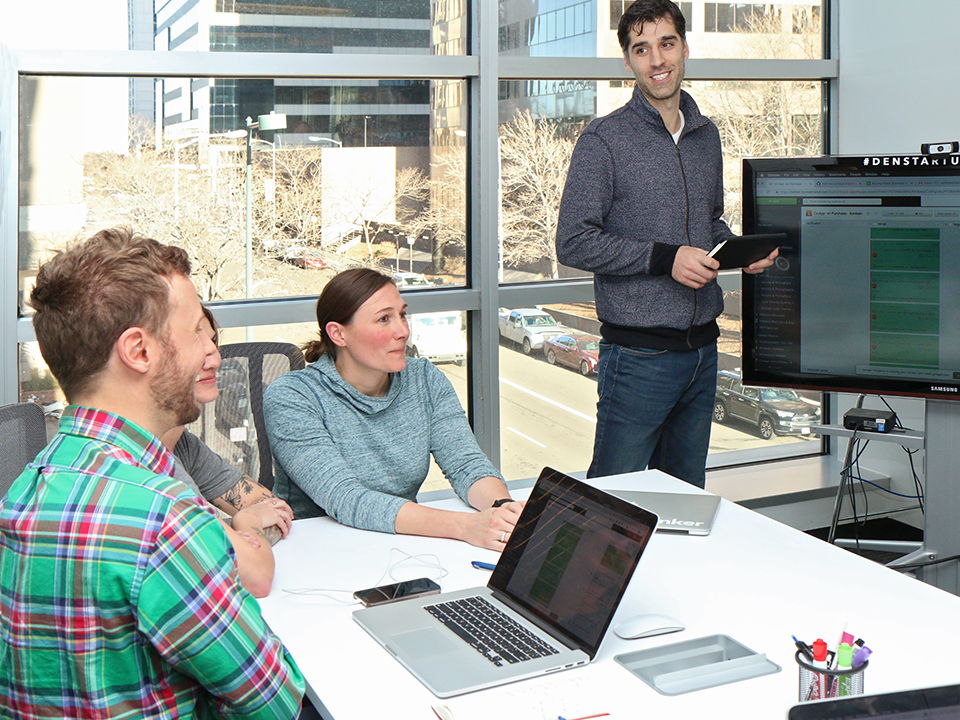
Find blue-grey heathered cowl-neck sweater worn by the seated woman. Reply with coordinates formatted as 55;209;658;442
263;355;502;533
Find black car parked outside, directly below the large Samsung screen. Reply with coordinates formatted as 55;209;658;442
713;370;820;440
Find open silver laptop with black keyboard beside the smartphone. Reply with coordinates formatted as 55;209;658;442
353;468;657;697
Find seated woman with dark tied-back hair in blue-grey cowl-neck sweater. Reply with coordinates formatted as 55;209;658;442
263;268;523;550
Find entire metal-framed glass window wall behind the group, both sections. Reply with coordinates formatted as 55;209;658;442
2;0;836;485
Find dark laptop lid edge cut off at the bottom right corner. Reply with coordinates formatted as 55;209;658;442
787;685;960;720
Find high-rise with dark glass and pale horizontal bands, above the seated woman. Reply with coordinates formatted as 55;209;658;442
155;0;431;147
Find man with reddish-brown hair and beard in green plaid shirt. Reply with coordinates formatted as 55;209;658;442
0;229;303;719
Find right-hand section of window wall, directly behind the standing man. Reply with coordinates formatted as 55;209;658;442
498;0;826;474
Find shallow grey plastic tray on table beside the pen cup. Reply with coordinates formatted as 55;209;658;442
613;635;781;695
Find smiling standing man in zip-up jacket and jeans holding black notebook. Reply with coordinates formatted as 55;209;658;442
557;0;776;487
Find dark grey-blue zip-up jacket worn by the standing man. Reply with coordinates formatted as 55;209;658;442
557;89;732;330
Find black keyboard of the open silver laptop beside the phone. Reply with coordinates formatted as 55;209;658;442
423;597;558;667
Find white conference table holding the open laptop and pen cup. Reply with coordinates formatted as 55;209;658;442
260;471;960;720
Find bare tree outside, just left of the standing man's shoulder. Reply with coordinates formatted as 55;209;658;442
500;111;574;278
